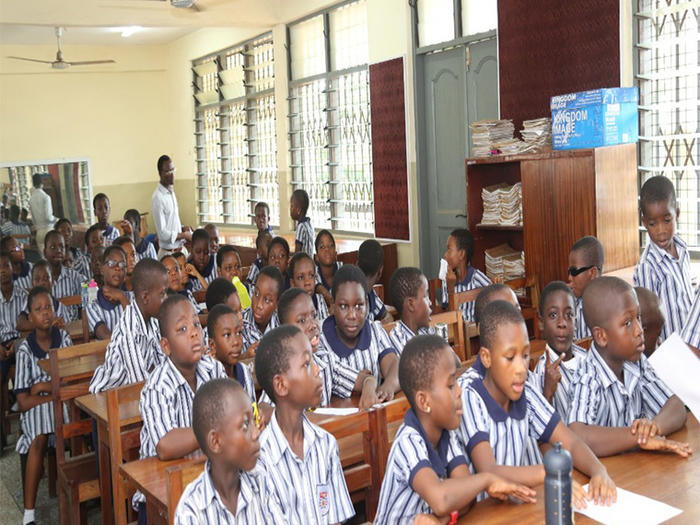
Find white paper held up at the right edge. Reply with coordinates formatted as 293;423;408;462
649;333;700;419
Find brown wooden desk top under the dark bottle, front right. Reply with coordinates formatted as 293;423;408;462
459;415;700;525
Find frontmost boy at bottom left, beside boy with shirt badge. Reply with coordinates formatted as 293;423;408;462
175;379;287;525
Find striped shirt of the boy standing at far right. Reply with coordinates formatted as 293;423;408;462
634;235;693;342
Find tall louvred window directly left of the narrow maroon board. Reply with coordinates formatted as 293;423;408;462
289;0;374;233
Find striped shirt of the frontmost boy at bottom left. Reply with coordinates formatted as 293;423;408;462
175;461;287;525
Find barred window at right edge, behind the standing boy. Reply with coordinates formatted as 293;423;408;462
635;0;700;250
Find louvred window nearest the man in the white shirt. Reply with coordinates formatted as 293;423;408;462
193;34;279;225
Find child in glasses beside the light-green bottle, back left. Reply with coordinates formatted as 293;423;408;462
85;244;131;339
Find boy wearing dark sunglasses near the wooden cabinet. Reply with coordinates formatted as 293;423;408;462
568;235;605;341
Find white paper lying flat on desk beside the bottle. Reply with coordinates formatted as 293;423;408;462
576;485;683;525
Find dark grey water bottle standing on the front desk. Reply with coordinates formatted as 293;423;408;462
544;442;574;525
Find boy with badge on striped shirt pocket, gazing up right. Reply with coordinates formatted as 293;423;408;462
255;325;355;525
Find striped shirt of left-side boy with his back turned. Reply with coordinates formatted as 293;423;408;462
90;302;165;394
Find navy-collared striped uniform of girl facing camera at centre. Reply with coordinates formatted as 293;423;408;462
318;315;396;383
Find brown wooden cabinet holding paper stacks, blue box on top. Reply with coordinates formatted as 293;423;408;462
466;144;639;288
